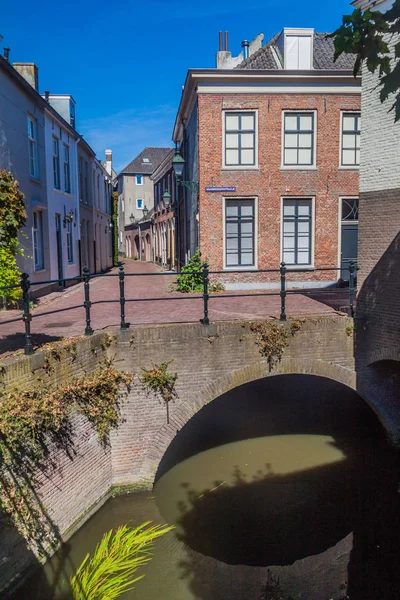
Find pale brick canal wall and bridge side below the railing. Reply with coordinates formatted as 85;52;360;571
0;316;393;595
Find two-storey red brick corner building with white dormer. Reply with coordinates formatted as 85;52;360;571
173;29;361;288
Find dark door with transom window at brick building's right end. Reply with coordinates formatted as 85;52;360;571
340;198;358;281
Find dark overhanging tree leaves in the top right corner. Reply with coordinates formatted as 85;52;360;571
329;0;400;121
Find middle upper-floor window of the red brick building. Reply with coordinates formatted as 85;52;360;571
283;112;314;167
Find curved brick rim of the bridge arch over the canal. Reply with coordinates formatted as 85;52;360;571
141;358;362;483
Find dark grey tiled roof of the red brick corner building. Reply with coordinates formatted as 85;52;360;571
235;33;355;70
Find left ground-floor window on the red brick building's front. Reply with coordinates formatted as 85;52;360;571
225;199;255;267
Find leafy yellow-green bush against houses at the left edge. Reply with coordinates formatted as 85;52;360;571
0;170;26;305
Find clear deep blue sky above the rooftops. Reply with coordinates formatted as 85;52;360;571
0;0;351;170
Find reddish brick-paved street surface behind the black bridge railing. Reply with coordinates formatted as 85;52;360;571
0;260;348;354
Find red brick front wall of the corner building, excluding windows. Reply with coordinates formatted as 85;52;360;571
199;94;361;281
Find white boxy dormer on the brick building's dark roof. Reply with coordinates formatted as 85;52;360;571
280;29;314;71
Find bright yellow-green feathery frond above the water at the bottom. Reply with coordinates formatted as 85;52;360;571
71;521;173;600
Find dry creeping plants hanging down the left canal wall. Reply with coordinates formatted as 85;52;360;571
0;368;132;556
